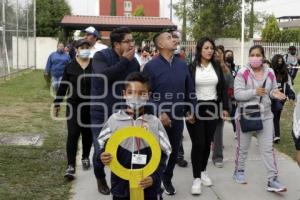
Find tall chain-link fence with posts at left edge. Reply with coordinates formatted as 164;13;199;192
0;0;36;77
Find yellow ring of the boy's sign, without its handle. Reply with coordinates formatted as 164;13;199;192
105;126;161;180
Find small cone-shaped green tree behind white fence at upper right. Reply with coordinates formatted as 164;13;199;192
262;15;281;42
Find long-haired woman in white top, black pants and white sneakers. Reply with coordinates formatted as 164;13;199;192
186;38;228;195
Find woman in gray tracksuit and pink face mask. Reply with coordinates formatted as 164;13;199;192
233;45;286;192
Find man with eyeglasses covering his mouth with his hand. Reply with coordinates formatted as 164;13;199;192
91;27;140;195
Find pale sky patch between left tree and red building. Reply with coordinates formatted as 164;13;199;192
67;0;99;16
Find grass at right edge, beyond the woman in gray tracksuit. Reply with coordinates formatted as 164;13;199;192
275;73;300;160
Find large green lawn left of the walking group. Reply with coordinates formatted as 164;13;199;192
0;71;71;200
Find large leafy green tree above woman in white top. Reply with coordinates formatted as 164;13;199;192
174;0;241;40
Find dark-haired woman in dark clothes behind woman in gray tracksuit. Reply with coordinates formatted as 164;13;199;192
272;54;295;143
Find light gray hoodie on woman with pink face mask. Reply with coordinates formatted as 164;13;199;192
234;64;277;120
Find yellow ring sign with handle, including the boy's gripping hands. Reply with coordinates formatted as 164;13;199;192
105;127;161;200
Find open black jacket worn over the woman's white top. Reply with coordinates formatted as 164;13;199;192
189;60;229;111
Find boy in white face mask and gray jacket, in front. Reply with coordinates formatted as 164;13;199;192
98;72;171;200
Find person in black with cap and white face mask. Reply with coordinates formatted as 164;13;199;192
54;39;93;180
